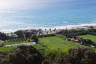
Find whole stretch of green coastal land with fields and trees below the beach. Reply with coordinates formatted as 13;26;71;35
0;27;96;64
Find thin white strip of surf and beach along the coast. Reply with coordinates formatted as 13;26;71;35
0;23;96;33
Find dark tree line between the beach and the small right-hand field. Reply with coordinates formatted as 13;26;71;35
57;29;96;36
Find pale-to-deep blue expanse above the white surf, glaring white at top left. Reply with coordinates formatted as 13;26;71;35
0;0;96;31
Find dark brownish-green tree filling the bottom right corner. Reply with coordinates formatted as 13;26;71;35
65;48;96;64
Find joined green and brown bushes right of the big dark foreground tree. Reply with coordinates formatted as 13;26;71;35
43;48;96;64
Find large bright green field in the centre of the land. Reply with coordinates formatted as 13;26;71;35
39;36;87;52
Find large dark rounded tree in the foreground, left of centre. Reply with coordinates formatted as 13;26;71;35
9;46;42;64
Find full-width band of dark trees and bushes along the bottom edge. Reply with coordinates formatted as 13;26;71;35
0;46;96;64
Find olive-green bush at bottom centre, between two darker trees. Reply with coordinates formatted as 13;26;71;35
42;50;65;64
